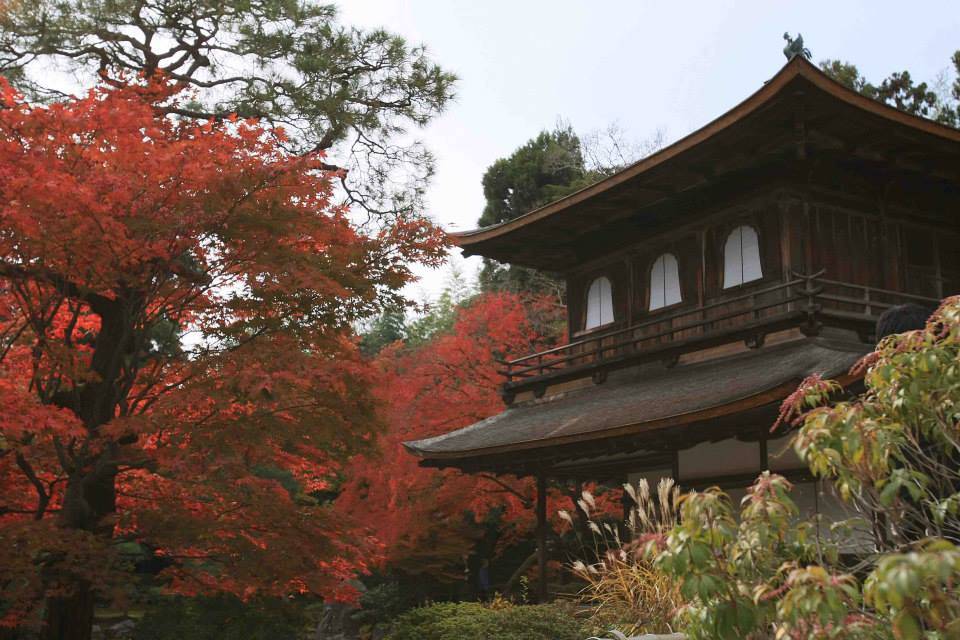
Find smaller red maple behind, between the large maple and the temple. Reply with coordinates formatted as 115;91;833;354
337;293;569;579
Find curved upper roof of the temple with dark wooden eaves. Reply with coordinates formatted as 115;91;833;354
451;56;960;271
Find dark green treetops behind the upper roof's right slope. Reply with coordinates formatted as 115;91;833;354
820;50;960;127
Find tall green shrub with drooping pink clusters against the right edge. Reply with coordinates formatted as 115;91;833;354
784;296;960;552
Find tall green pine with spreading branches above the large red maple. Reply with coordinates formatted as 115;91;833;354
0;0;456;213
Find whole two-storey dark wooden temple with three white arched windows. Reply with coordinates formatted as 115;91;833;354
406;56;960;594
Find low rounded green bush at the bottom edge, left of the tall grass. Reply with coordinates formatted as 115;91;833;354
388;602;586;640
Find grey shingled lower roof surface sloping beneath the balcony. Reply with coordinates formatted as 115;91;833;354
404;339;869;460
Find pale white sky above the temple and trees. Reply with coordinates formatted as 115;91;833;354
337;0;960;299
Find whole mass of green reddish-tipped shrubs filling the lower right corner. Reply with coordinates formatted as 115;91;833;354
648;297;960;640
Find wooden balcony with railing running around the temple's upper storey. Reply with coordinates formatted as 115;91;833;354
501;271;939;404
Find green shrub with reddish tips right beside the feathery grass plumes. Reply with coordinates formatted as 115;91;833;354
655;472;840;640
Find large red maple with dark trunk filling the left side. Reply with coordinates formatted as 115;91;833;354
0;77;443;638
